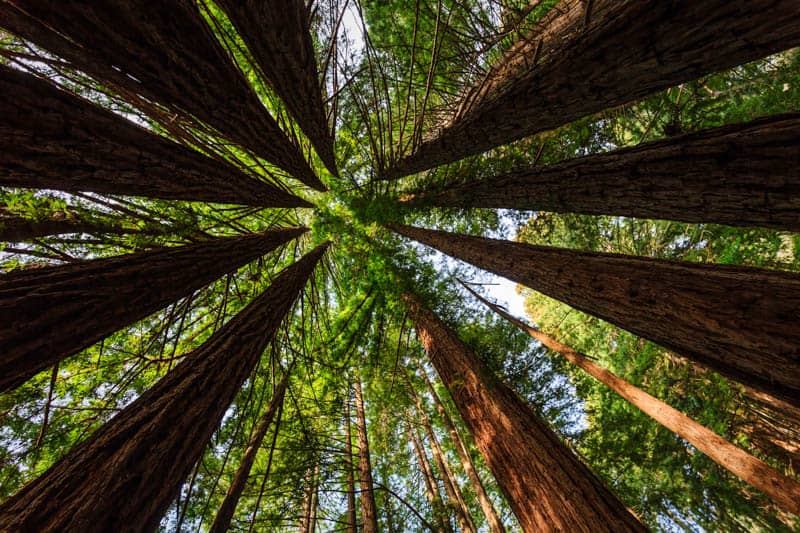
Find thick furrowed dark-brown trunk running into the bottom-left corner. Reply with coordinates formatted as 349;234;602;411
0;245;324;532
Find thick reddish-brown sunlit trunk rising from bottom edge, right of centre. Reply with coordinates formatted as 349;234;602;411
406;295;645;532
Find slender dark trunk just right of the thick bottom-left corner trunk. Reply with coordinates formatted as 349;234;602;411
208;371;290;533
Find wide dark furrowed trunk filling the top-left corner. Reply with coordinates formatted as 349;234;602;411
0;0;325;190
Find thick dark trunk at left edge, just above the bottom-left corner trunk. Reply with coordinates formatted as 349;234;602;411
0;228;307;392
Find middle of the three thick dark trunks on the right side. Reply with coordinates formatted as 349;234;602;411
413;113;800;231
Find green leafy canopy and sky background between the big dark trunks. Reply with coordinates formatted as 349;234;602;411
0;0;800;532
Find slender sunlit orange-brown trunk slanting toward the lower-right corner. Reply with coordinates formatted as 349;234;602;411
462;283;800;516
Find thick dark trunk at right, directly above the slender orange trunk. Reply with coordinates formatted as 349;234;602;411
391;225;800;405
